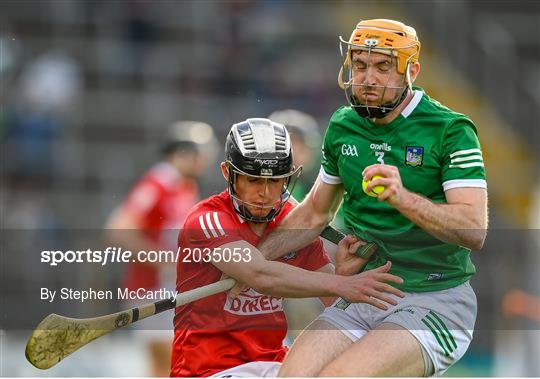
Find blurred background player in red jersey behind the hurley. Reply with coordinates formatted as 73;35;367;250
107;121;217;376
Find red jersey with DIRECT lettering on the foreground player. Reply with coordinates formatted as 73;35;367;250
171;191;330;377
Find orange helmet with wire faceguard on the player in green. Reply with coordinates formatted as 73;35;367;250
338;19;420;118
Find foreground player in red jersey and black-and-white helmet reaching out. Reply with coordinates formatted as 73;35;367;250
171;118;402;377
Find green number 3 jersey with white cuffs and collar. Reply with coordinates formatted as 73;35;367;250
320;88;486;292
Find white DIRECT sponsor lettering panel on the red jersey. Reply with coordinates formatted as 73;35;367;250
223;288;283;315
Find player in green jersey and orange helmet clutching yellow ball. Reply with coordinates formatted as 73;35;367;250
255;19;487;376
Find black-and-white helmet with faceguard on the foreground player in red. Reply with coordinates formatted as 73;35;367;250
225;118;302;222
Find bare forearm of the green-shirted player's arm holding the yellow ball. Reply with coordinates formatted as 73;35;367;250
396;192;486;250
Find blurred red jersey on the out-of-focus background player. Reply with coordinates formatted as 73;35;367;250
122;162;199;290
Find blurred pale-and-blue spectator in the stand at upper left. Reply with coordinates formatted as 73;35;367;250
6;51;82;177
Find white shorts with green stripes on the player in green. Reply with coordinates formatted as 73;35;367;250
317;282;477;376
